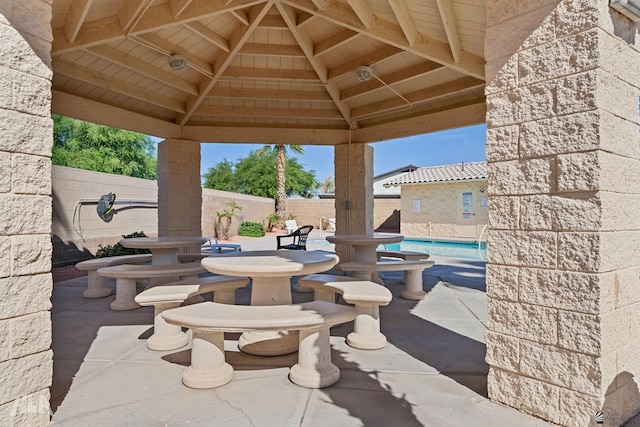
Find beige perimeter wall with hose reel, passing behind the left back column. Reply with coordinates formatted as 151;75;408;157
50;166;274;266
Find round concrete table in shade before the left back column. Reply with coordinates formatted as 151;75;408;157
119;236;209;286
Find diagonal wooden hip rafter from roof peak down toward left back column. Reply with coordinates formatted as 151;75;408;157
178;0;273;126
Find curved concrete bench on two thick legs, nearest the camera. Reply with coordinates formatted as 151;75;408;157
162;301;358;389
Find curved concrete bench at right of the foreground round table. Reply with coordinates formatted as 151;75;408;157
298;274;392;350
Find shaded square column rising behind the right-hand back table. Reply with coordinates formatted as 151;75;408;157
334;143;373;262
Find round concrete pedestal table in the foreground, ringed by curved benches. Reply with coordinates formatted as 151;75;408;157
202;251;340;356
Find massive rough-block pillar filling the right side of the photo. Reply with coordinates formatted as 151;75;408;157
485;0;640;426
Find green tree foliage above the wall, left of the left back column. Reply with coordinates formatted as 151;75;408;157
51;114;158;179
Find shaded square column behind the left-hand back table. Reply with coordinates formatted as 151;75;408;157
158;139;201;236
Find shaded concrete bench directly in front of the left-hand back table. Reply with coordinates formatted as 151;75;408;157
98;262;207;310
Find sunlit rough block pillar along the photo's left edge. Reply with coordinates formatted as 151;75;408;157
0;0;53;426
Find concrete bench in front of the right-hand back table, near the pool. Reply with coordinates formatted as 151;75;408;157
339;260;434;300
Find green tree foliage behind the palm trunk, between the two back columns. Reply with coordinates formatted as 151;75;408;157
204;150;318;200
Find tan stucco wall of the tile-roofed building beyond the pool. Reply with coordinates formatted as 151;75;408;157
400;180;489;239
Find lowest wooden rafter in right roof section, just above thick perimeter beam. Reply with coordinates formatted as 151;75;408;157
351;77;484;119
